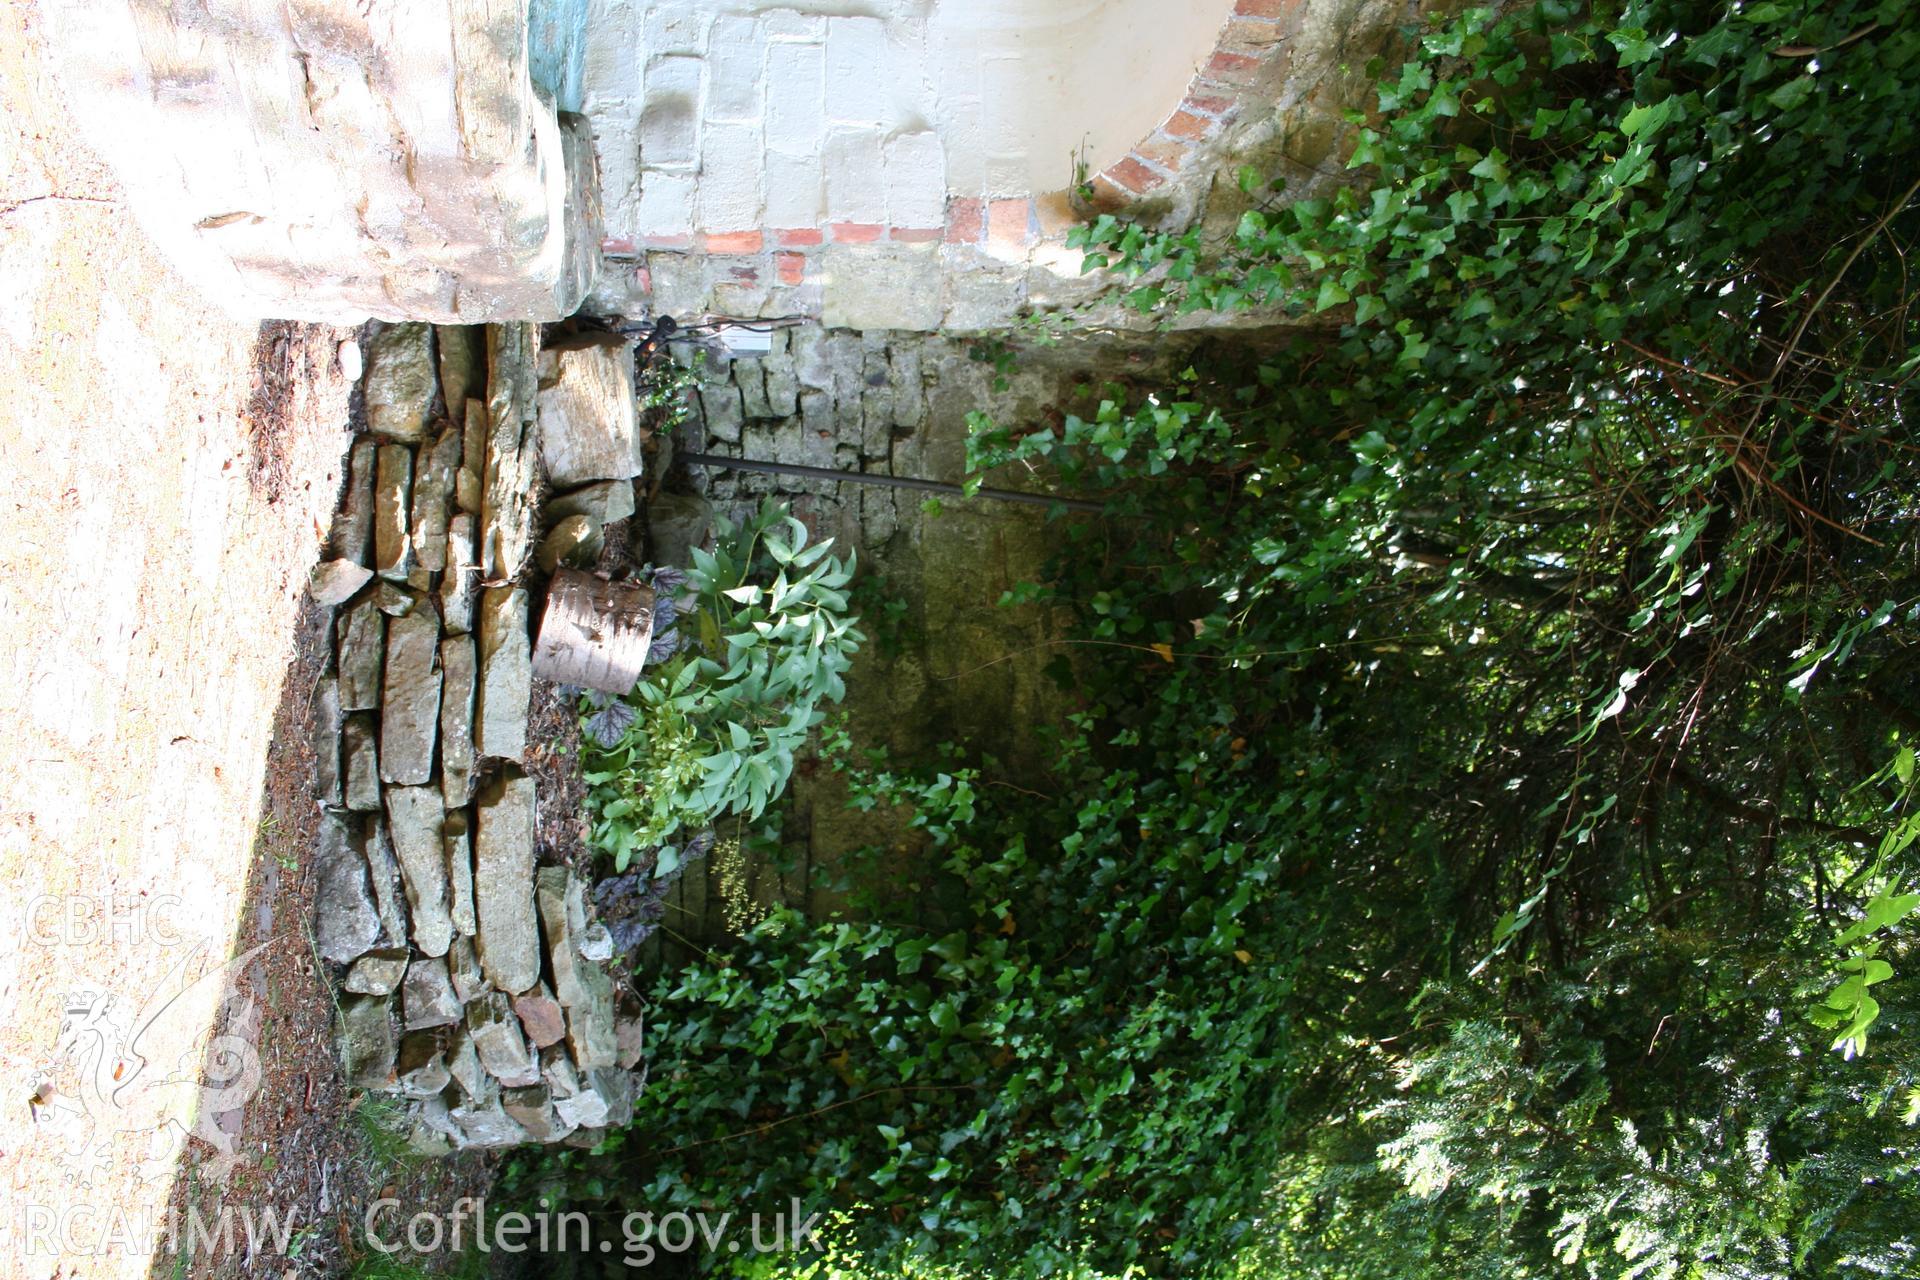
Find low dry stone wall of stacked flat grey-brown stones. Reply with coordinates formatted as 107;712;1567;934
311;324;643;1151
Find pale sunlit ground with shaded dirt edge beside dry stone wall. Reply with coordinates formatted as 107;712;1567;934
0;4;486;1280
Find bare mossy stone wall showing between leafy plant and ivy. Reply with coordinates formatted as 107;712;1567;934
649;326;1192;961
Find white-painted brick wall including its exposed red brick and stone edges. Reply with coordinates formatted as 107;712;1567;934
586;0;1405;332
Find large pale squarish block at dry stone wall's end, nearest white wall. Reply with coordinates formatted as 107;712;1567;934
540;334;641;487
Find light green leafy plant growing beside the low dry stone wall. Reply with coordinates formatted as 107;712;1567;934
582;501;862;875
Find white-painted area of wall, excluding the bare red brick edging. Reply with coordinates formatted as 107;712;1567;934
584;0;1233;240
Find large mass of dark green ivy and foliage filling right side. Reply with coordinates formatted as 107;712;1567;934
529;0;1920;1280
